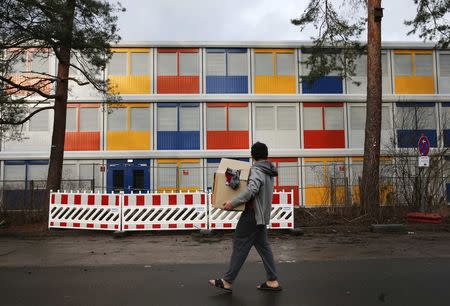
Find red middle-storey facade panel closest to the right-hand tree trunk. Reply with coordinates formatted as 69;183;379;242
304;130;345;149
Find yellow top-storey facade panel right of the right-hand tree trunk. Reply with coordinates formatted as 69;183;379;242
395;76;434;94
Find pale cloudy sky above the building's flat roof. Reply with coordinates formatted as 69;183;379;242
115;0;420;41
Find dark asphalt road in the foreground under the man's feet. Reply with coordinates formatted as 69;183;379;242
0;255;450;306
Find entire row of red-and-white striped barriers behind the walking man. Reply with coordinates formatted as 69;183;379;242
49;191;294;231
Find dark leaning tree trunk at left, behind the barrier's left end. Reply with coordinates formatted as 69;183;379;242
46;0;75;207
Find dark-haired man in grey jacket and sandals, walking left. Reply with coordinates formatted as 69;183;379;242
209;142;282;292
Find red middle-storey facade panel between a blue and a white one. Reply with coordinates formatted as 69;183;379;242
206;131;249;149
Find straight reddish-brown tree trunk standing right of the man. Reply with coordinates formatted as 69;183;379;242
361;0;382;214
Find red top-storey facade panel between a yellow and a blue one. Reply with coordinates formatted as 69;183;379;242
157;75;200;94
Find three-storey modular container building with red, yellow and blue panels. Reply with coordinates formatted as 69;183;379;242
0;41;450;207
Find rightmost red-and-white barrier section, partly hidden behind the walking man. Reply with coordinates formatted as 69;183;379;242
208;191;294;230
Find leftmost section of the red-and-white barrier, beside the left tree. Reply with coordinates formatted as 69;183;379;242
48;192;122;230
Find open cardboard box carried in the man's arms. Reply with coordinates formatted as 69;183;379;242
211;158;251;210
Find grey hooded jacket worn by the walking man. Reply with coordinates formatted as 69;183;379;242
231;160;278;225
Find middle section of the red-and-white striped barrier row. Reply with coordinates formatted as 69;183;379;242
122;192;208;231
